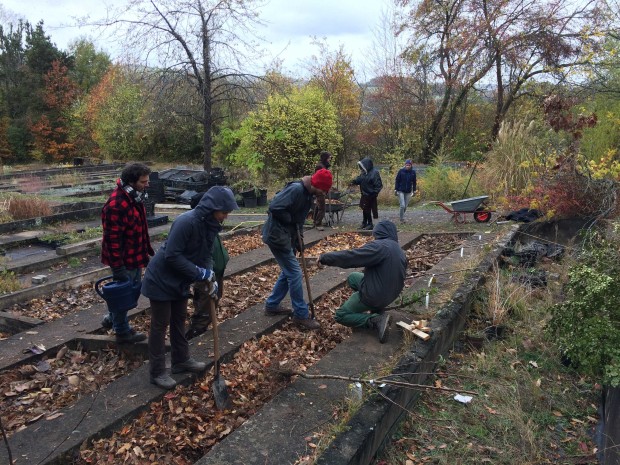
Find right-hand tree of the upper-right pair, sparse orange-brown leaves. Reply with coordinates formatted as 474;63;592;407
479;0;605;139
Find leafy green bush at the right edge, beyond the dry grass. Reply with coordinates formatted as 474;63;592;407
548;225;620;387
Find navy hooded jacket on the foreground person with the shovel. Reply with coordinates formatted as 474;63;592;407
142;186;239;301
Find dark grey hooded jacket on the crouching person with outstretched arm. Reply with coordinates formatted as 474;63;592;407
320;220;407;308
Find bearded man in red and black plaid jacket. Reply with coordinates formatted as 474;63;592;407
101;163;155;343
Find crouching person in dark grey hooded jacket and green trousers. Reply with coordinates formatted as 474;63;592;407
318;220;407;343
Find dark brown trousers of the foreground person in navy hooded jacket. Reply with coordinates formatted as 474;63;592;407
149;299;189;377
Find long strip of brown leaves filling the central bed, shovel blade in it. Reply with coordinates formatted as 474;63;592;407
77;289;350;465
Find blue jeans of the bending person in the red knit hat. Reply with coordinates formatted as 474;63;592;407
265;247;309;319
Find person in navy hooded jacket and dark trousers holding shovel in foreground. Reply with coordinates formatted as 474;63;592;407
142;186;239;389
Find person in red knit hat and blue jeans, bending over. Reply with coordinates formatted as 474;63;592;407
262;168;333;331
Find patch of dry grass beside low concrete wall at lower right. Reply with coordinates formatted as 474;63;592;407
374;262;600;465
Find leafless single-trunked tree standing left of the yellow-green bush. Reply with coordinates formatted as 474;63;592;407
97;0;263;171
